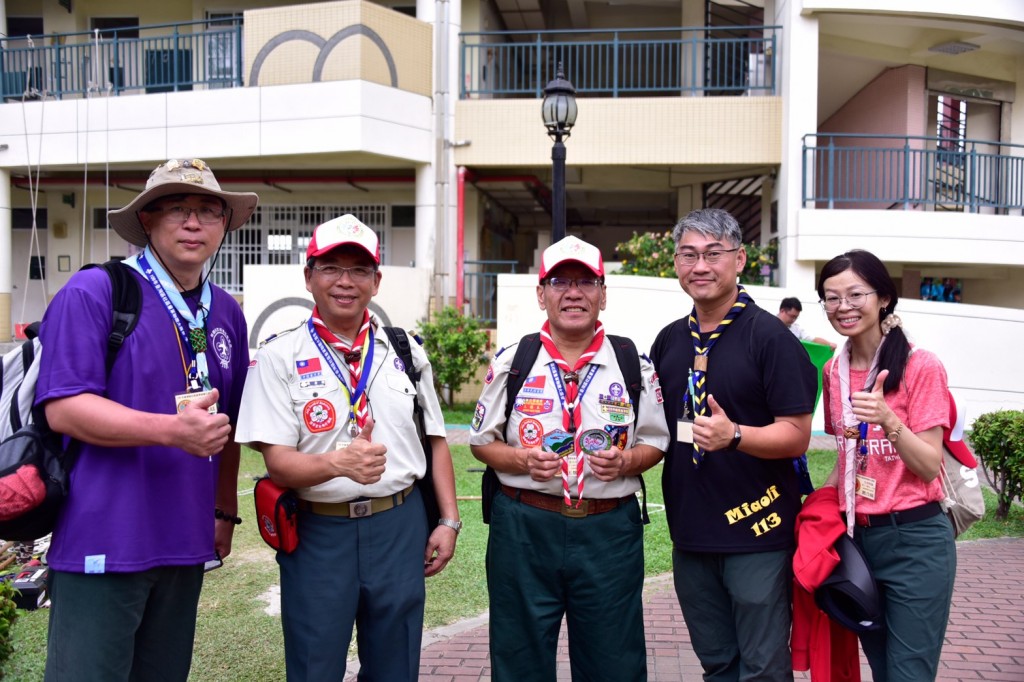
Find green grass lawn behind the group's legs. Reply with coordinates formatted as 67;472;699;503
4;440;1024;682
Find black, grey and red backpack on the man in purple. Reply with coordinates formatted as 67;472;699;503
0;260;142;541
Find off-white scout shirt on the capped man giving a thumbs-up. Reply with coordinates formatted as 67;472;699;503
236;318;444;503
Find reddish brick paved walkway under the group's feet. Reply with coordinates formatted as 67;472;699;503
348;539;1024;682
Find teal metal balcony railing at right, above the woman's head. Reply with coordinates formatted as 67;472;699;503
803;133;1024;215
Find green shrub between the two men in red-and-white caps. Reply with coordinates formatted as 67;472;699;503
420;305;487;408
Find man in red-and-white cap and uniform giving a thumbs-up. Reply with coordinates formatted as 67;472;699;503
238;215;462;682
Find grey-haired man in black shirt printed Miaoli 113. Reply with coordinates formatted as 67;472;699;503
651;209;817;680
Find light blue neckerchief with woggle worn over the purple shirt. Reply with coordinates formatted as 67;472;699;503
124;246;213;391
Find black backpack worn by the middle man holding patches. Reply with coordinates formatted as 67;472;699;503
480;333;650;524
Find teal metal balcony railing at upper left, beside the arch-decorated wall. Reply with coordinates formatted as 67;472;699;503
0;18;242;101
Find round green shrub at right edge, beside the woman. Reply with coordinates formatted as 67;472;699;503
971;410;1024;521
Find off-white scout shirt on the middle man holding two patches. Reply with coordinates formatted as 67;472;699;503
469;338;670;500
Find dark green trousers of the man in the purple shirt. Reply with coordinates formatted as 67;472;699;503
45;564;203;682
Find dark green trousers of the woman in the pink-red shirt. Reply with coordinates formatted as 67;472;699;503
853;514;956;682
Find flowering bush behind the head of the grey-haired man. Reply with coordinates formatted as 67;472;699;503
616;231;778;286
